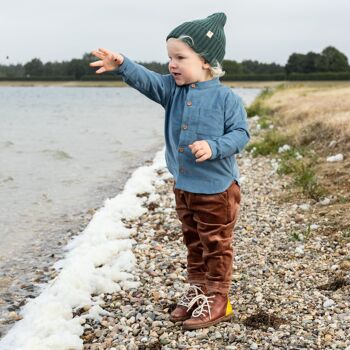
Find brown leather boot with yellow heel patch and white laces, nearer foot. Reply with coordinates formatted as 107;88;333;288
182;293;233;329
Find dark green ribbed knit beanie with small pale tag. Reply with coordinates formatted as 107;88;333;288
166;12;226;66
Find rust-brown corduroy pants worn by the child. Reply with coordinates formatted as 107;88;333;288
174;182;241;294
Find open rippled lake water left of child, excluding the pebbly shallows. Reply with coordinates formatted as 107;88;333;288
0;87;163;260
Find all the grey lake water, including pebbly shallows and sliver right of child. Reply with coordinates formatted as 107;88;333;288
0;87;259;337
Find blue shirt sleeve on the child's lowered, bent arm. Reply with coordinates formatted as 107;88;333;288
206;92;250;159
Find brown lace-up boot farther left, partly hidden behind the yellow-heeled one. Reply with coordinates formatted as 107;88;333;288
170;284;205;322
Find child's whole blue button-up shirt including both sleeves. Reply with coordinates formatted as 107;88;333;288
114;56;250;194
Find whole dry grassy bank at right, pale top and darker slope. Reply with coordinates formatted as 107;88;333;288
264;82;350;241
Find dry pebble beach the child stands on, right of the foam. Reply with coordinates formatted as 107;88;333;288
78;116;350;350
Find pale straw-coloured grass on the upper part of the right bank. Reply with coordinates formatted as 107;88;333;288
266;85;350;151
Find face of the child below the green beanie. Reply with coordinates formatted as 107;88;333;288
167;38;212;85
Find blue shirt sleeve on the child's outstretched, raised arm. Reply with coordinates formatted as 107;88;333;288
113;55;175;108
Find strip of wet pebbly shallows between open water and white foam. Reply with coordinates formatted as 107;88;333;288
0;147;163;343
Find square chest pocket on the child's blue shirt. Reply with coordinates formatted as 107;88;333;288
196;108;225;136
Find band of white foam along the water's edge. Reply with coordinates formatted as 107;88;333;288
0;150;169;350
